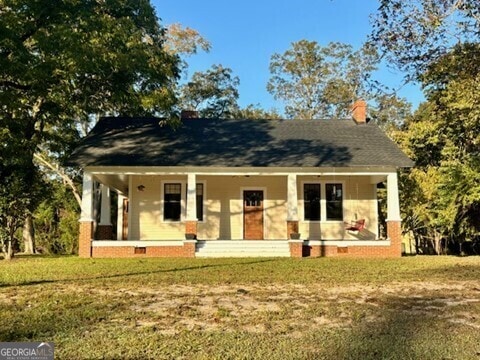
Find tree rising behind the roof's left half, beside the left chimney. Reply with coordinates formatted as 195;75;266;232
180;65;240;118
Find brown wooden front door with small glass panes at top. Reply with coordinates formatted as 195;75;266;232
243;190;263;240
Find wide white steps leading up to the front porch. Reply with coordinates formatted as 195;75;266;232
195;240;290;257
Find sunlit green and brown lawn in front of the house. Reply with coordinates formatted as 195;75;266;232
0;257;480;360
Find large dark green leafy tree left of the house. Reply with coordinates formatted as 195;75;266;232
0;0;179;258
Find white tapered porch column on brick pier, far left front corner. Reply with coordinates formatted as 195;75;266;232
78;171;93;257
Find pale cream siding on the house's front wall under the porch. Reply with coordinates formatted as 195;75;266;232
129;175;378;240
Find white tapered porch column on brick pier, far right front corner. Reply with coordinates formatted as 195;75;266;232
386;172;402;256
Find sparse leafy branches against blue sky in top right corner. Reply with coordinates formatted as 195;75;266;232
370;0;480;79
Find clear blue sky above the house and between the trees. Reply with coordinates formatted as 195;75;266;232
152;0;423;111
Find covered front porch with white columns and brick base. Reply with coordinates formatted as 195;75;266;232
79;167;400;257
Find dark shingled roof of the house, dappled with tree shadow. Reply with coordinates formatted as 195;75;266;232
68;117;413;167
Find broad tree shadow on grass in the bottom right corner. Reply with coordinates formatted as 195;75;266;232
338;296;480;360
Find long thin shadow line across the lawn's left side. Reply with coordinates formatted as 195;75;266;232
0;258;277;288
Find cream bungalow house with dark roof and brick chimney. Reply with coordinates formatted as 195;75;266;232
69;101;413;257
